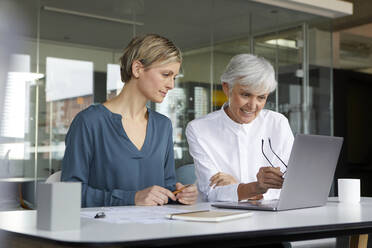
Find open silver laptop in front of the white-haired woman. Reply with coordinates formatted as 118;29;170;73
212;134;343;211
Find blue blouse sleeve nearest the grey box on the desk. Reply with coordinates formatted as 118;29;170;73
61;114;136;207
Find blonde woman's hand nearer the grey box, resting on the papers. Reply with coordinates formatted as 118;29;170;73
134;185;176;206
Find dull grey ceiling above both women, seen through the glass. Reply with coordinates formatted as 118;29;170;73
17;0;326;51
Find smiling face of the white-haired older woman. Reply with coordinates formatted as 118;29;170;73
222;83;269;124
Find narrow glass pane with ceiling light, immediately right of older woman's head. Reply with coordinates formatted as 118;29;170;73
253;26;307;133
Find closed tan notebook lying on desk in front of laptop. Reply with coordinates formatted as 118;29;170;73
166;210;252;222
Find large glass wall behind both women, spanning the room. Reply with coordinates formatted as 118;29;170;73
0;0;332;206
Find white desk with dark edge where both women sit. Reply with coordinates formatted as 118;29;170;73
0;198;372;247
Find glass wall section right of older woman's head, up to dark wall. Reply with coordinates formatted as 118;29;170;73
253;22;333;135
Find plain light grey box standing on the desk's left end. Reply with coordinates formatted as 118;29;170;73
37;182;81;231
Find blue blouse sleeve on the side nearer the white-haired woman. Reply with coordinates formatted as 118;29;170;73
164;121;176;191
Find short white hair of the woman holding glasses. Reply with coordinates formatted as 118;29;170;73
221;54;277;95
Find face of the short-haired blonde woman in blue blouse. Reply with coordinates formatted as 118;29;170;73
138;62;181;103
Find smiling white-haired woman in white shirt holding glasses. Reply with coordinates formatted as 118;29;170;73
186;54;294;201
